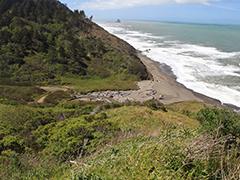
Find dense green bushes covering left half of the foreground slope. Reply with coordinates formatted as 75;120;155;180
0;101;123;160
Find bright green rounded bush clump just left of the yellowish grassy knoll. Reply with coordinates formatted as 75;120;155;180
34;114;116;160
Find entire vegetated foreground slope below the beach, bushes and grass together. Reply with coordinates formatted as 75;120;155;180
0;101;240;179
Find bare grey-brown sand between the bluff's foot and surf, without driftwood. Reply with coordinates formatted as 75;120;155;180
138;52;222;106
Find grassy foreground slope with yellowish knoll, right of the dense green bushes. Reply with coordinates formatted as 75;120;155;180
72;102;240;179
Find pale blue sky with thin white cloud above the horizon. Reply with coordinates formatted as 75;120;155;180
60;0;240;24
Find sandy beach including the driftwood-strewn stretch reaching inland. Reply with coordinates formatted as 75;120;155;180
75;53;221;105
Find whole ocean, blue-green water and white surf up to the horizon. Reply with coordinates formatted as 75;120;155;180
98;21;240;107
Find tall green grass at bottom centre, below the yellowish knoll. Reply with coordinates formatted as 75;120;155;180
73;129;193;179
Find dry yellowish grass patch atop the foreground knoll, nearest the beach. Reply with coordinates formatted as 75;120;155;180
106;106;199;136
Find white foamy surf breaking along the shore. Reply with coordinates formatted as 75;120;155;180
100;23;240;107
